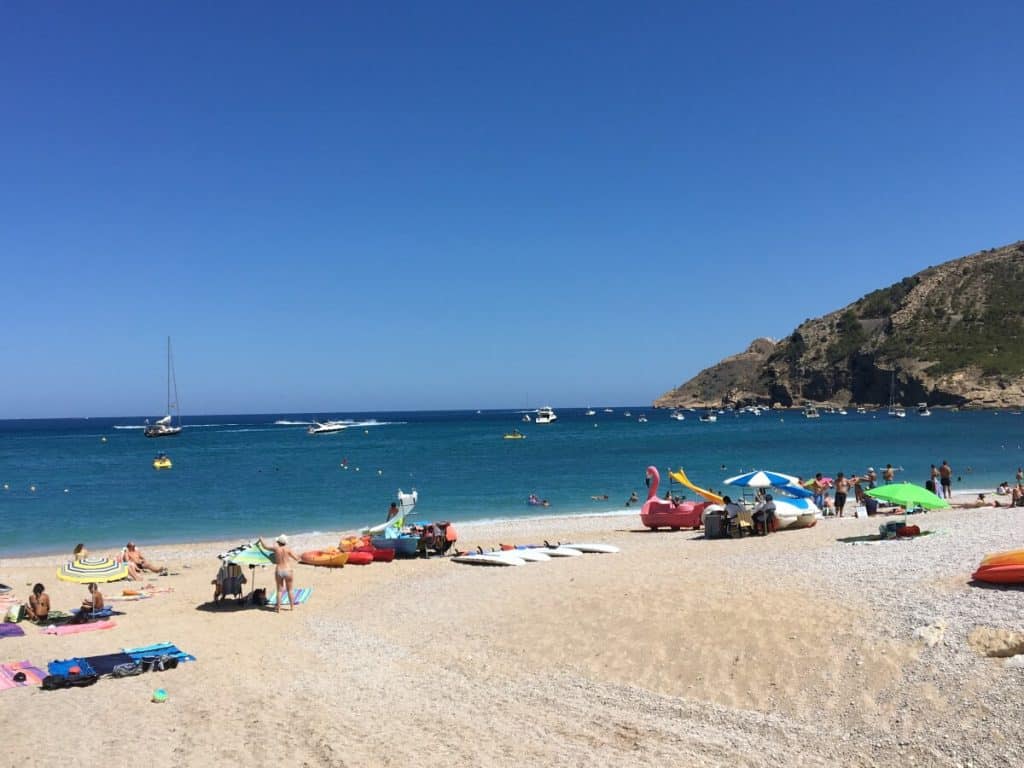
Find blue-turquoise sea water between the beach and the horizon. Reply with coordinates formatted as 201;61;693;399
0;407;1024;555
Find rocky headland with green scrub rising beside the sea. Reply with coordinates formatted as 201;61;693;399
654;241;1024;408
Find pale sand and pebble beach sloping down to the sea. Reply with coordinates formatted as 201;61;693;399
0;495;1024;767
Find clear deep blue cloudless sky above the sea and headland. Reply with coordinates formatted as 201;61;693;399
0;2;1024;418
